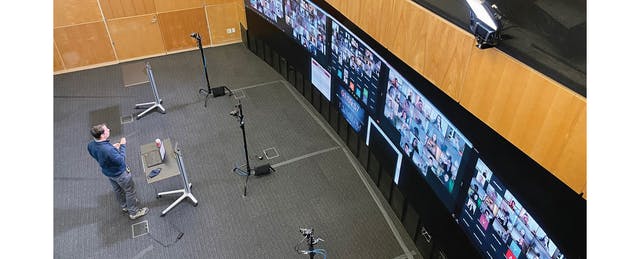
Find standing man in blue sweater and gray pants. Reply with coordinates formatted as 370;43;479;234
87;123;149;219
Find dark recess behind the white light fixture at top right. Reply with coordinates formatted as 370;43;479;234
413;0;587;98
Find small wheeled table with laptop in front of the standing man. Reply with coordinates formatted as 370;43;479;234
140;138;198;217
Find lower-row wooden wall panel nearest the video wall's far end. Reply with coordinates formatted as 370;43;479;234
207;3;242;45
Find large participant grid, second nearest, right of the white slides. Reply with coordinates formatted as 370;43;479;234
384;68;471;193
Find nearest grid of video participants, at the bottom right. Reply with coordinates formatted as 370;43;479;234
461;160;564;259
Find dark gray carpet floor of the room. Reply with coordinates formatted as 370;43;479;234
53;44;420;258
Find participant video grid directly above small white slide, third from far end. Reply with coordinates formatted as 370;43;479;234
331;21;382;114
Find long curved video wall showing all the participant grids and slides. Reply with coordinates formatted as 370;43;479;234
246;0;566;258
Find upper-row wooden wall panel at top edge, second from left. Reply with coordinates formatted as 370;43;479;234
100;0;156;20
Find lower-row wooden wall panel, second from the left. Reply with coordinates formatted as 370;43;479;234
107;14;165;60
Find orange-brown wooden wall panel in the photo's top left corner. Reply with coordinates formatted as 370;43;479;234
53;0;102;28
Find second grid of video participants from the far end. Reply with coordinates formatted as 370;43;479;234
284;0;327;58
